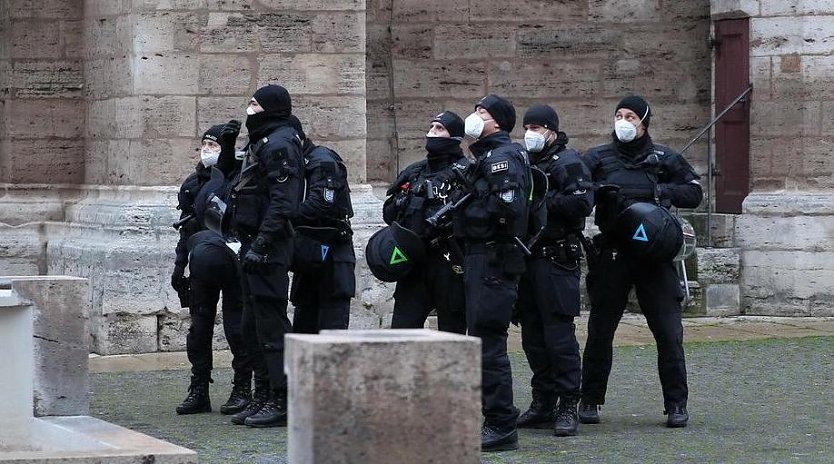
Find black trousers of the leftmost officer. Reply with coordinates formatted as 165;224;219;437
186;239;252;379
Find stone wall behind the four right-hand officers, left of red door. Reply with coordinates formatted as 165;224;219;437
366;0;711;182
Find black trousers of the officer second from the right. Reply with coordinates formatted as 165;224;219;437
517;257;581;399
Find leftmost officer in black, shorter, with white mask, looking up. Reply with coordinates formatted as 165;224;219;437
171;120;252;414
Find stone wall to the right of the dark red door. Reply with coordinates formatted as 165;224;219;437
712;0;834;316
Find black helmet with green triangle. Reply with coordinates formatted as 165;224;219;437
365;222;426;282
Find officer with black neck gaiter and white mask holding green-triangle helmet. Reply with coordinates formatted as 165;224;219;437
383;111;471;333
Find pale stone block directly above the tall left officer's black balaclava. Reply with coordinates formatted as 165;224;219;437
258;54;365;96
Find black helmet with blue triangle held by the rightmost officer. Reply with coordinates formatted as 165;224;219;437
613;202;683;261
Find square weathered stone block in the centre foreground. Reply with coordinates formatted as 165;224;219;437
285;330;481;464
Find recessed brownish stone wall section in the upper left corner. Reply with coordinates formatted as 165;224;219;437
0;0;85;183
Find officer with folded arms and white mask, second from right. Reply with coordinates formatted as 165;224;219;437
518;105;594;436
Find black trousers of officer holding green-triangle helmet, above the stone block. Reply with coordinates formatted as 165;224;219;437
391;246;466;333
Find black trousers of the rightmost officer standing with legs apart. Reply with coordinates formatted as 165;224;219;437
582;250;689;410
